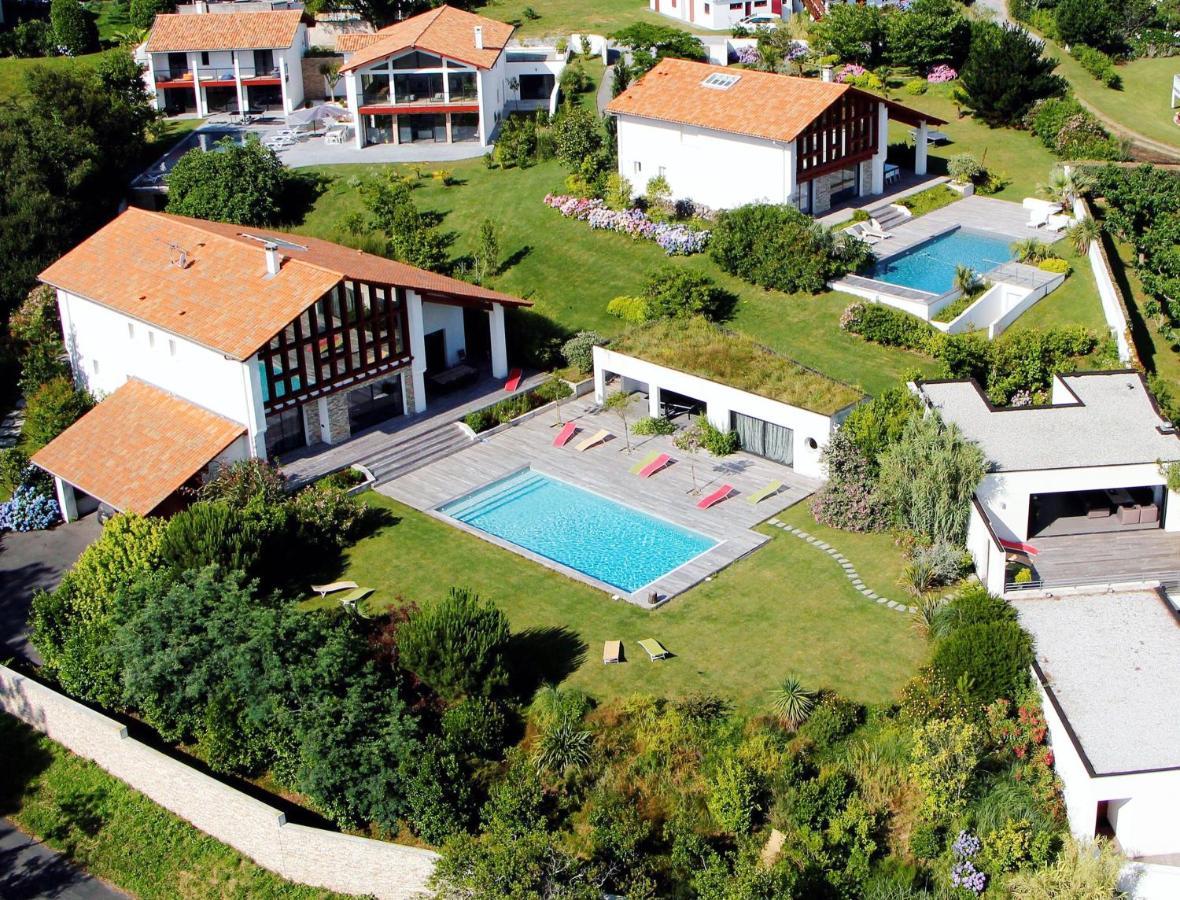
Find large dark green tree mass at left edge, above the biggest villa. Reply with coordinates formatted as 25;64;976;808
0;52;157;316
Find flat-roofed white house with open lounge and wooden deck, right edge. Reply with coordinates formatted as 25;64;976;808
916;372;1180;594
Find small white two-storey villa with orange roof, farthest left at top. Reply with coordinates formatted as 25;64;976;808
139;2;308;116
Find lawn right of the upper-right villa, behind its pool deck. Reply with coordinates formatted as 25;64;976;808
890;85;1058;203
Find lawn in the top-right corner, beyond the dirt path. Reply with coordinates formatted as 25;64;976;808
1045;40;1180;150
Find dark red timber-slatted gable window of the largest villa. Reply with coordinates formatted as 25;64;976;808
260;281;408;409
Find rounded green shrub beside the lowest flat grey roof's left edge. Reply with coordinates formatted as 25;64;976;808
933;622;1033;705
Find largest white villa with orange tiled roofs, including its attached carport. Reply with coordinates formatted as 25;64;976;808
33;206;529;519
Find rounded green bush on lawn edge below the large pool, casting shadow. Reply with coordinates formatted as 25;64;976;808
398;587;509;699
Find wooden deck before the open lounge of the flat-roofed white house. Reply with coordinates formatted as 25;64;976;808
1033;528;1180;587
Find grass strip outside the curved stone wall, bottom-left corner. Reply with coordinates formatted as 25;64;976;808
0;715;342;900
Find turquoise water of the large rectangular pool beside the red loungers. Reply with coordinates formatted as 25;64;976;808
439;468;716;593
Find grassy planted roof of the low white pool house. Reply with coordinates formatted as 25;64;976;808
610;318;861;415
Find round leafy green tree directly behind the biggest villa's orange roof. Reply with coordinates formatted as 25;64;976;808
168;138;289;225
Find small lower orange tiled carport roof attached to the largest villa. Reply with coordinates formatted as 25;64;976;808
33;379;245;515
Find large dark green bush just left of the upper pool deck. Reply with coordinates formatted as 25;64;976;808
709;202;872;294
